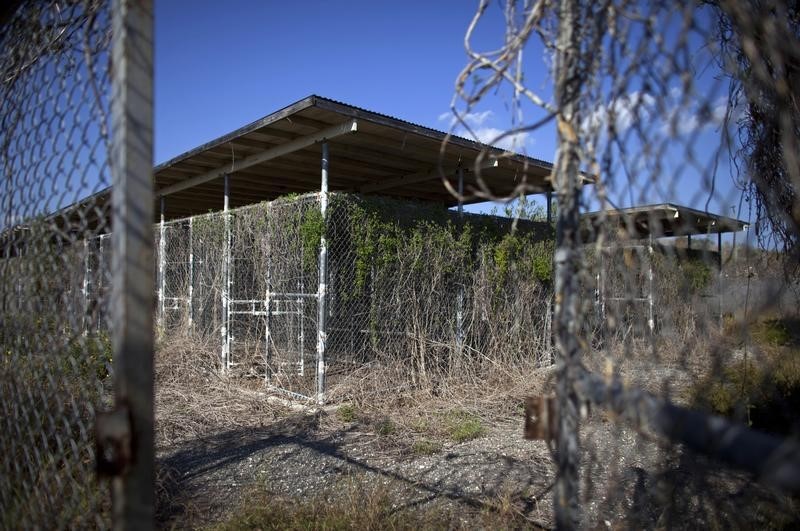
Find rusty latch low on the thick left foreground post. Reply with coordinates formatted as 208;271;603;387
95;405;131;477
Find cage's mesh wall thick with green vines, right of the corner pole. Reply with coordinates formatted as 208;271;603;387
326;194;552;399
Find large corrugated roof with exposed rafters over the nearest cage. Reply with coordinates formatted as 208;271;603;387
155;95;552;218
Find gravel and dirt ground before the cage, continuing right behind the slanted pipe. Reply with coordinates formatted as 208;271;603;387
152;396;796;529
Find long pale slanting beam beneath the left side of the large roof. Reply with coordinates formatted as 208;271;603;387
155;120;358;197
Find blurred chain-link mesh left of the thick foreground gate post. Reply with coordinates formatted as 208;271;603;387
0;1;111;529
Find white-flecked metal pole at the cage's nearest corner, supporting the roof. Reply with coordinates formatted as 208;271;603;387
317;141;328;404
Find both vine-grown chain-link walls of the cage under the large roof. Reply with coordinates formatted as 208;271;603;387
150;194;553;400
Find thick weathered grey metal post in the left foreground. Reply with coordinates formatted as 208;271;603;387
111;0;155;529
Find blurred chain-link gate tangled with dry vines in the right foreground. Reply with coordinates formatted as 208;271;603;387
453;0;800;527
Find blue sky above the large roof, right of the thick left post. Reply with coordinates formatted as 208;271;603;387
155;0;748;233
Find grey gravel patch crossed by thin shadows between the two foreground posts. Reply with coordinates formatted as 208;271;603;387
157;415;551;527
